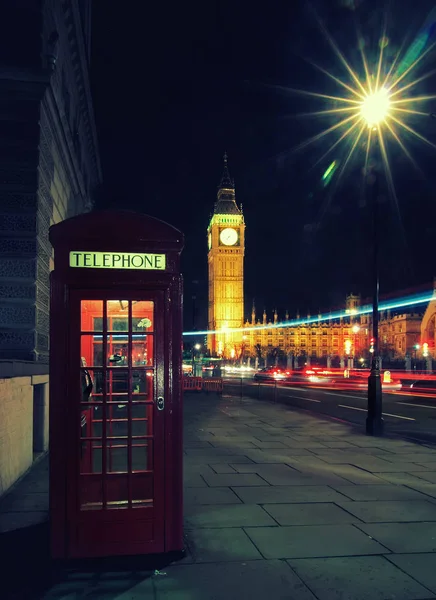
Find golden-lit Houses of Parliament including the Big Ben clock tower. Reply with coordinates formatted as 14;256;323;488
207;154;430;360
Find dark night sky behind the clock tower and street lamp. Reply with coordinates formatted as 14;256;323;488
91;0;436;329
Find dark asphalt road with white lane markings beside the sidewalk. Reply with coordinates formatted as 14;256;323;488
225;378;436;444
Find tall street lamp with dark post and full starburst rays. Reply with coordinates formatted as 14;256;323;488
282;10;436;435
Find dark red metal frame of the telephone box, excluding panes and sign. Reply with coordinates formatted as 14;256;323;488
50;211;183;558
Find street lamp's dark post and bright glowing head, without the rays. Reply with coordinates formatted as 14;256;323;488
361;88;390;436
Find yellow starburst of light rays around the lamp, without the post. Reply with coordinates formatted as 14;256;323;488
280;11;436;220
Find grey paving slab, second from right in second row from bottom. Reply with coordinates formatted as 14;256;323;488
245;524;388;559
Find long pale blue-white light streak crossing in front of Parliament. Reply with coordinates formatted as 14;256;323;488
183;290;436;336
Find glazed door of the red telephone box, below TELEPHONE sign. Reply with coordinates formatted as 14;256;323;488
66;290;167;558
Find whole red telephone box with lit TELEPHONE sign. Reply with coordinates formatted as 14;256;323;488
50;211;183;559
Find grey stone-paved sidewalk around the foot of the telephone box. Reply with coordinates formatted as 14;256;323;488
0;393;436;600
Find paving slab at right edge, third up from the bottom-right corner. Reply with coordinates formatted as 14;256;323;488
338;500;436;523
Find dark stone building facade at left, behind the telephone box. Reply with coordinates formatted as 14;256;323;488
0;0;101;493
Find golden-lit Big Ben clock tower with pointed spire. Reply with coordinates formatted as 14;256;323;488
207;154;245;358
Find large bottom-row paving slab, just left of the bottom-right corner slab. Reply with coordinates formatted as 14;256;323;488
288;556;435;600
